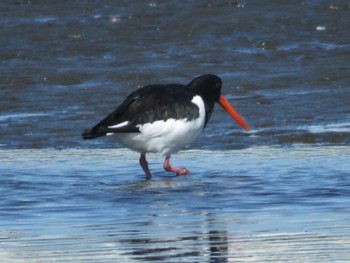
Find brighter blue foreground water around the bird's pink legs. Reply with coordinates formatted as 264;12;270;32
0;146;350;262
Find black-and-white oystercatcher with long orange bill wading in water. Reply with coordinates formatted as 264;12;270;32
82;74;249;179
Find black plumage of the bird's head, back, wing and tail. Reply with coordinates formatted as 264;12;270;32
83;75;221;139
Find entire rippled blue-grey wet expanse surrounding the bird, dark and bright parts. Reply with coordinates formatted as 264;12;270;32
0;0;350;262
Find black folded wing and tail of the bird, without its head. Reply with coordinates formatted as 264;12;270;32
83;84;199;139
